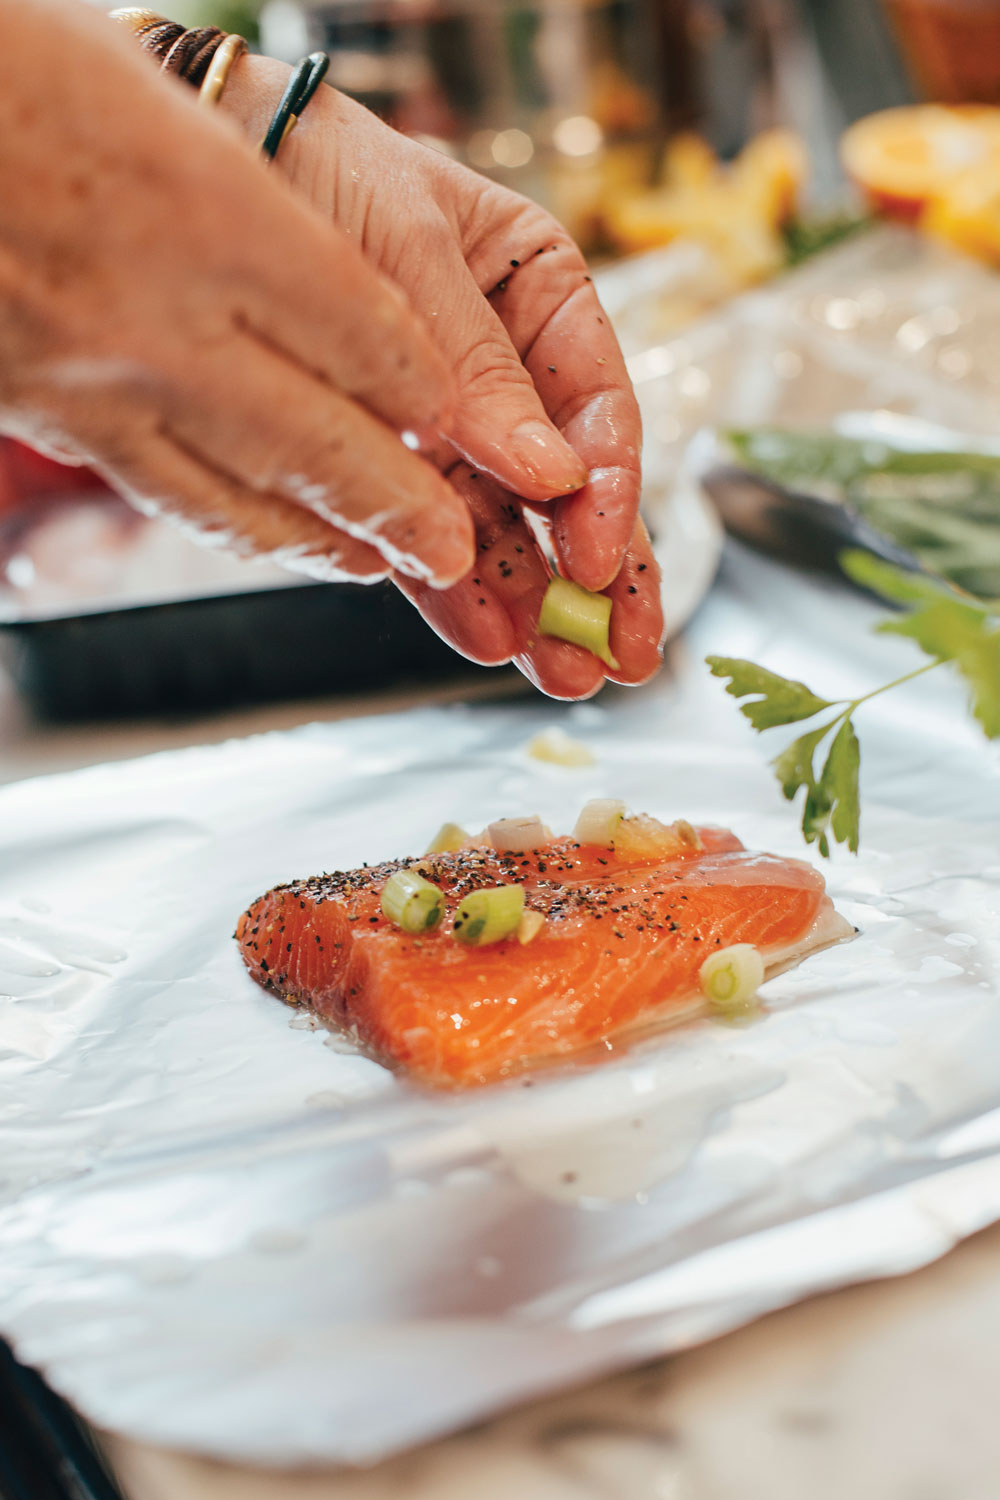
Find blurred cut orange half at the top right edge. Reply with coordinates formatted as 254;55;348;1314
841;104;1000;222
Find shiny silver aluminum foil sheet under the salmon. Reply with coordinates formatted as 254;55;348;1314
0;551;1000;1464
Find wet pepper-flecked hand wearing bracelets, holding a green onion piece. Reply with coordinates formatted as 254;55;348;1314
225;59;663;698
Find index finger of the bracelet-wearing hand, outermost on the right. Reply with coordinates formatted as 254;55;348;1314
474;214;642;590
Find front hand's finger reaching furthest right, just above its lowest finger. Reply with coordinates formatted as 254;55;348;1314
162;333;474;587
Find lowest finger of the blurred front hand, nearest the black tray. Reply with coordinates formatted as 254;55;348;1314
86;431;388;584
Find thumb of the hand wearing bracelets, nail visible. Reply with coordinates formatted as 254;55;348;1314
410;239;586;500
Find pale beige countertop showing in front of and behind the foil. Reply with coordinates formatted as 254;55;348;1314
0;677;1000;1500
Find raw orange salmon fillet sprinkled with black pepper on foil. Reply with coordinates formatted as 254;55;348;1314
235;828;853;1088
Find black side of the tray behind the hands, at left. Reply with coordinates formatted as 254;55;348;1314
0;584;500;720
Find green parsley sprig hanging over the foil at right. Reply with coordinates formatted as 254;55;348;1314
706;552;1000;858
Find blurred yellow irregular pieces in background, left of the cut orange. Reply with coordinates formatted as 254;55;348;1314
604;131;807;288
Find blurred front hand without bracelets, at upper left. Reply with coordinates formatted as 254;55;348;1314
0;0;474;588
